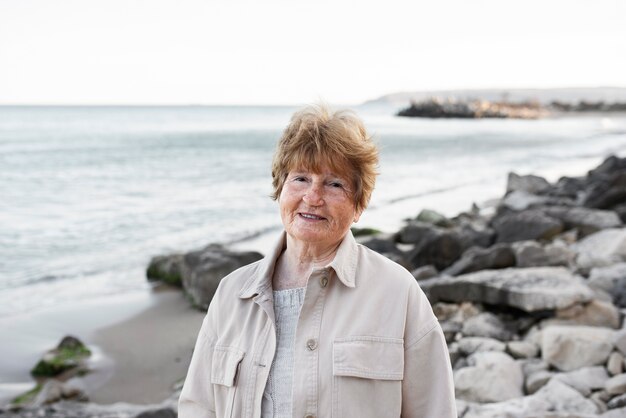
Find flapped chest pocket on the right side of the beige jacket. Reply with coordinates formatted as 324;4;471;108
332;336;404;418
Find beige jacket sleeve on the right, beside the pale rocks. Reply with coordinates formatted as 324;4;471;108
402;283;457;418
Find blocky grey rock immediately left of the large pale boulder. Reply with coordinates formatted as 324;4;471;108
513;241;575;267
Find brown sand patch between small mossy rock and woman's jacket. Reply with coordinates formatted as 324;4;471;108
90;289;204;404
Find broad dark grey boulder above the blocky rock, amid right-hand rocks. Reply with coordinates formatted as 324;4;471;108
492;209;563;242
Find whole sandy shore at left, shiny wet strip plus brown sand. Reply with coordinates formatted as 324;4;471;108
0;287;204;405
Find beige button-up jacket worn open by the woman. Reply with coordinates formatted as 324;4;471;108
178;232;457;418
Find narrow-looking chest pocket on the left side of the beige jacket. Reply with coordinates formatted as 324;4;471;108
211;345;245;418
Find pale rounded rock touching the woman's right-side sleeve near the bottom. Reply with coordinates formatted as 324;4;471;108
454;351;524;402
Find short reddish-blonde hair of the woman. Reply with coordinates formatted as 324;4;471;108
272;104;378;212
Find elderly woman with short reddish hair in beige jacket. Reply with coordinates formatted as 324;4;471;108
179;106;456;418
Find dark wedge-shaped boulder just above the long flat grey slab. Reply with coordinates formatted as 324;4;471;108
443;244;515;276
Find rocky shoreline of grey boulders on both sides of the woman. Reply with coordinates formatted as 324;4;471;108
7;157;626;418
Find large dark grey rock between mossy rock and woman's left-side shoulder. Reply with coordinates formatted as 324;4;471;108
182;244;263;310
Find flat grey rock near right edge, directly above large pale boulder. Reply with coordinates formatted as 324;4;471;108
543;206;622;236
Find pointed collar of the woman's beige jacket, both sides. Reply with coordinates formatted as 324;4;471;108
239;230;359;299
